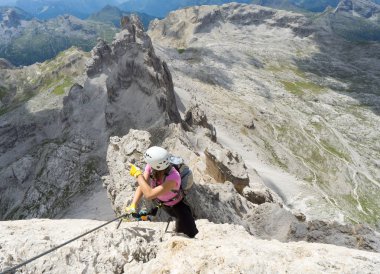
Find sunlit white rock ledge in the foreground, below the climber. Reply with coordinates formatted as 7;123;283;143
0;219;380;274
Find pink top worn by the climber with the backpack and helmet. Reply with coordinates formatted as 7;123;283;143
145;164;182;206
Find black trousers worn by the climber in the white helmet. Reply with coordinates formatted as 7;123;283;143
163;200;198;238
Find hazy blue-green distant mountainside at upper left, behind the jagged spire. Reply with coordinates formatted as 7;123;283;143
0;8;116;66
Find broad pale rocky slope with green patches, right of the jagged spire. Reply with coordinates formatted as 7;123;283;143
148;1;380;227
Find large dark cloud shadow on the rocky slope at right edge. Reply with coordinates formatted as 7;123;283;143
295;16;380;115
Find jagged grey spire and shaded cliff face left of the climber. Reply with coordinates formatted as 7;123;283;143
0;15;180;219
